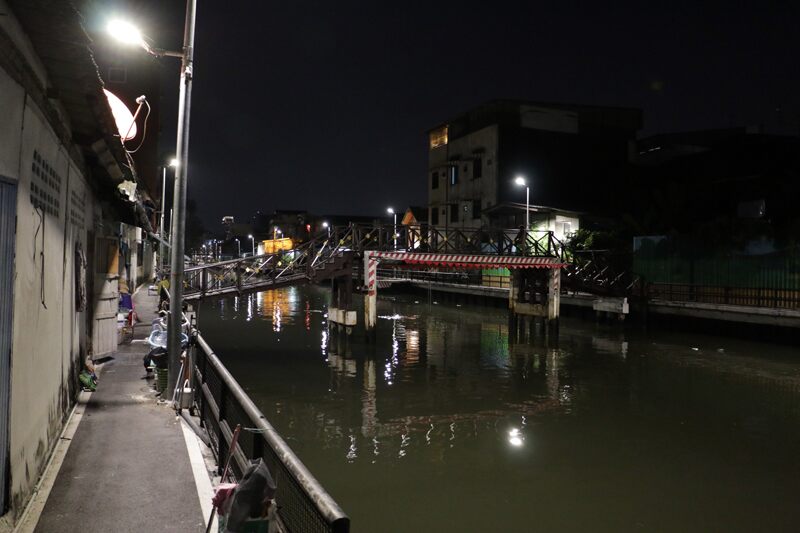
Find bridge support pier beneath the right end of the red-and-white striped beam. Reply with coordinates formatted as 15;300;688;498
508;268;561;340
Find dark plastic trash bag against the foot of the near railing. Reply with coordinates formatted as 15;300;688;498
225;459;276;533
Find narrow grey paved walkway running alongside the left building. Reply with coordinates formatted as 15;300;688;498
36;288;205;533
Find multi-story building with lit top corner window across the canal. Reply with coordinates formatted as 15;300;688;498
428;100;641;228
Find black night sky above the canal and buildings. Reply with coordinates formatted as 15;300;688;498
114;0;800;230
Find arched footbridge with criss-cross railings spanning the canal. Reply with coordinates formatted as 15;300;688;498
184;224;637;301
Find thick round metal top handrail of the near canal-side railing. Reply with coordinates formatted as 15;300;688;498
194;333;350;533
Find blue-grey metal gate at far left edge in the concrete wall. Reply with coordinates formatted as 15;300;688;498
0;176;17;514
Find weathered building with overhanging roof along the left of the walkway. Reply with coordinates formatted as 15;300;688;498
0;0;152;530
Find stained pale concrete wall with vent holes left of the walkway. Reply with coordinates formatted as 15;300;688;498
0;4;106;527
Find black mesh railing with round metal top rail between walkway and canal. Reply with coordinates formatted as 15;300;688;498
192;334;350;533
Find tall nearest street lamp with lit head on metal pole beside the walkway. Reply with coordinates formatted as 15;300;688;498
108;0;197;397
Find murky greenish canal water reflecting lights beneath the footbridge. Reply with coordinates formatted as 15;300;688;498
200;286;800;532
